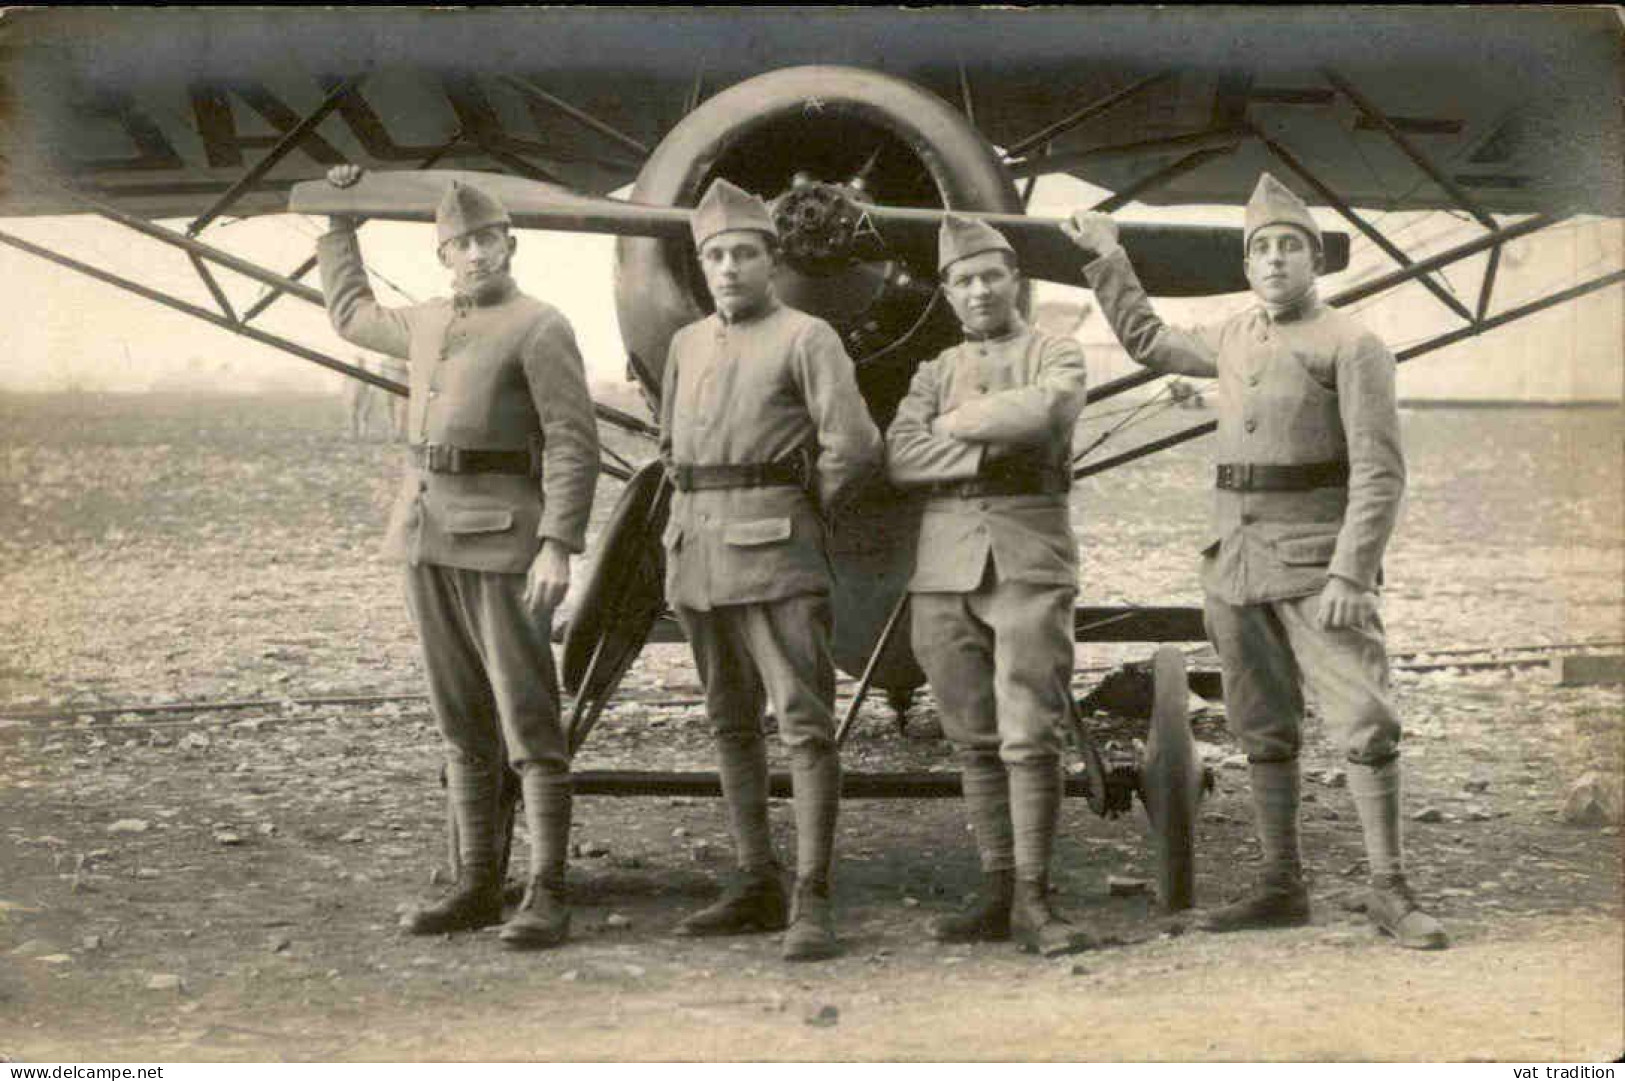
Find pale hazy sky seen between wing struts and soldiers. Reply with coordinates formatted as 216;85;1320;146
0;177;1625;398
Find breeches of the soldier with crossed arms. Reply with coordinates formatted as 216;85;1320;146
908;572;1077;764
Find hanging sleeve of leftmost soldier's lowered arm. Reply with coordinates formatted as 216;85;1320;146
523;312;598;553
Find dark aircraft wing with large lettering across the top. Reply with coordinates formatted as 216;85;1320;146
0;7;1625;218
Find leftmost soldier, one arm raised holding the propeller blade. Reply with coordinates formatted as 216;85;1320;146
317;166;598;949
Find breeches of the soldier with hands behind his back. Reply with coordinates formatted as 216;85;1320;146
676;593;835;748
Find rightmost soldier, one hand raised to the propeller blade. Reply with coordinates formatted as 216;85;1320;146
1061;174;1448;949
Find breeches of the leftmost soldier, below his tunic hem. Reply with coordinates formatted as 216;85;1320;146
406;564;570;769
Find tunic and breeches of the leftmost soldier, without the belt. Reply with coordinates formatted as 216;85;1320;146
317;231;598;766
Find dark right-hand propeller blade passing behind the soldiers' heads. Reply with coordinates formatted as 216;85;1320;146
858;206;1349;296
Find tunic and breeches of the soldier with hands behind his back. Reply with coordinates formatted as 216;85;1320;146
660;301;881;746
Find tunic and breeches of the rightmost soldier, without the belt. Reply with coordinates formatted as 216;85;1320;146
1084;249;1406;766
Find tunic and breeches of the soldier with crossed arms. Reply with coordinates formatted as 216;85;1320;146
886;320;1087;762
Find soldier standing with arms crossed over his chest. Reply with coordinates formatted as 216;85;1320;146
886;215;1090;956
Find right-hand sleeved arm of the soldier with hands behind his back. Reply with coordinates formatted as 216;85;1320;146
796;320;882;510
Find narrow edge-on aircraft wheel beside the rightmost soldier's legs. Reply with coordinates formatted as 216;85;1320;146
1139;645;1203;912
